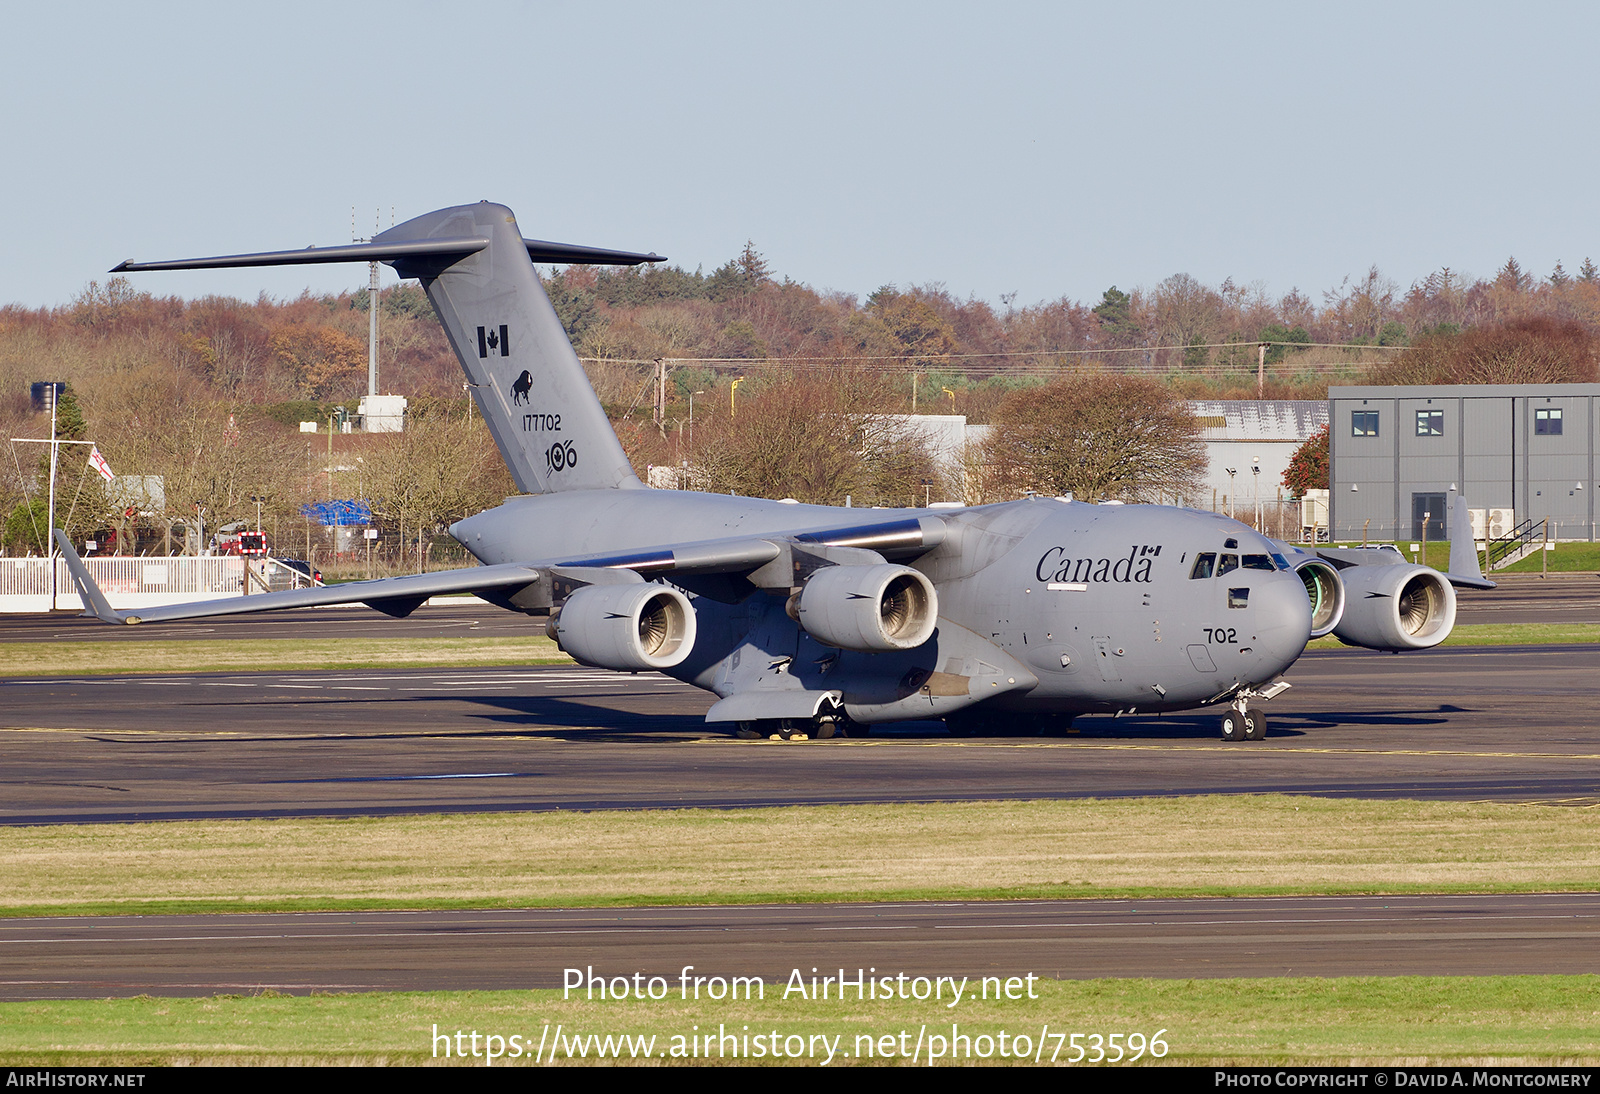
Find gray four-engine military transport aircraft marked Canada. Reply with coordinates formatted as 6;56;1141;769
56;202;1493;741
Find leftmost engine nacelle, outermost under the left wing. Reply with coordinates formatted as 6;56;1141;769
550;582;694;672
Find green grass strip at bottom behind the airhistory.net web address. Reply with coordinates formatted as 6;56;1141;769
0;972;1600;1067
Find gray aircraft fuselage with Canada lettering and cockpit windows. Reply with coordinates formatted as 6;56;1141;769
451;489;1310;721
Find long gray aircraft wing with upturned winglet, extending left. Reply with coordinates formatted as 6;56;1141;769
56;517;947;624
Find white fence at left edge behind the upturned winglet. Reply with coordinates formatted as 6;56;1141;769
0;555;245;613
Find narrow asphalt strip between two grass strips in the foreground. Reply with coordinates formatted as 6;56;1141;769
0;894;1600;1020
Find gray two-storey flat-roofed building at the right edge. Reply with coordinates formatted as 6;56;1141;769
1328;384;1600;541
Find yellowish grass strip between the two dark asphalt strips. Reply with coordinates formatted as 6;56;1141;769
0;795;1600;915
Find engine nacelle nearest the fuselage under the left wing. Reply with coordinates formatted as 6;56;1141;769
795;563;939;653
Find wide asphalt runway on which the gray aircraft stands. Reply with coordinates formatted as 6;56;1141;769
0;646;1600;824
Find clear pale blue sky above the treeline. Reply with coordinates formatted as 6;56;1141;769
0;2;1600;305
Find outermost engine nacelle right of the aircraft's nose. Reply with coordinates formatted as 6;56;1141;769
1333;565;1456;649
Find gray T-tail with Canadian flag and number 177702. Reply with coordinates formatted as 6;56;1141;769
112;202;662;494
